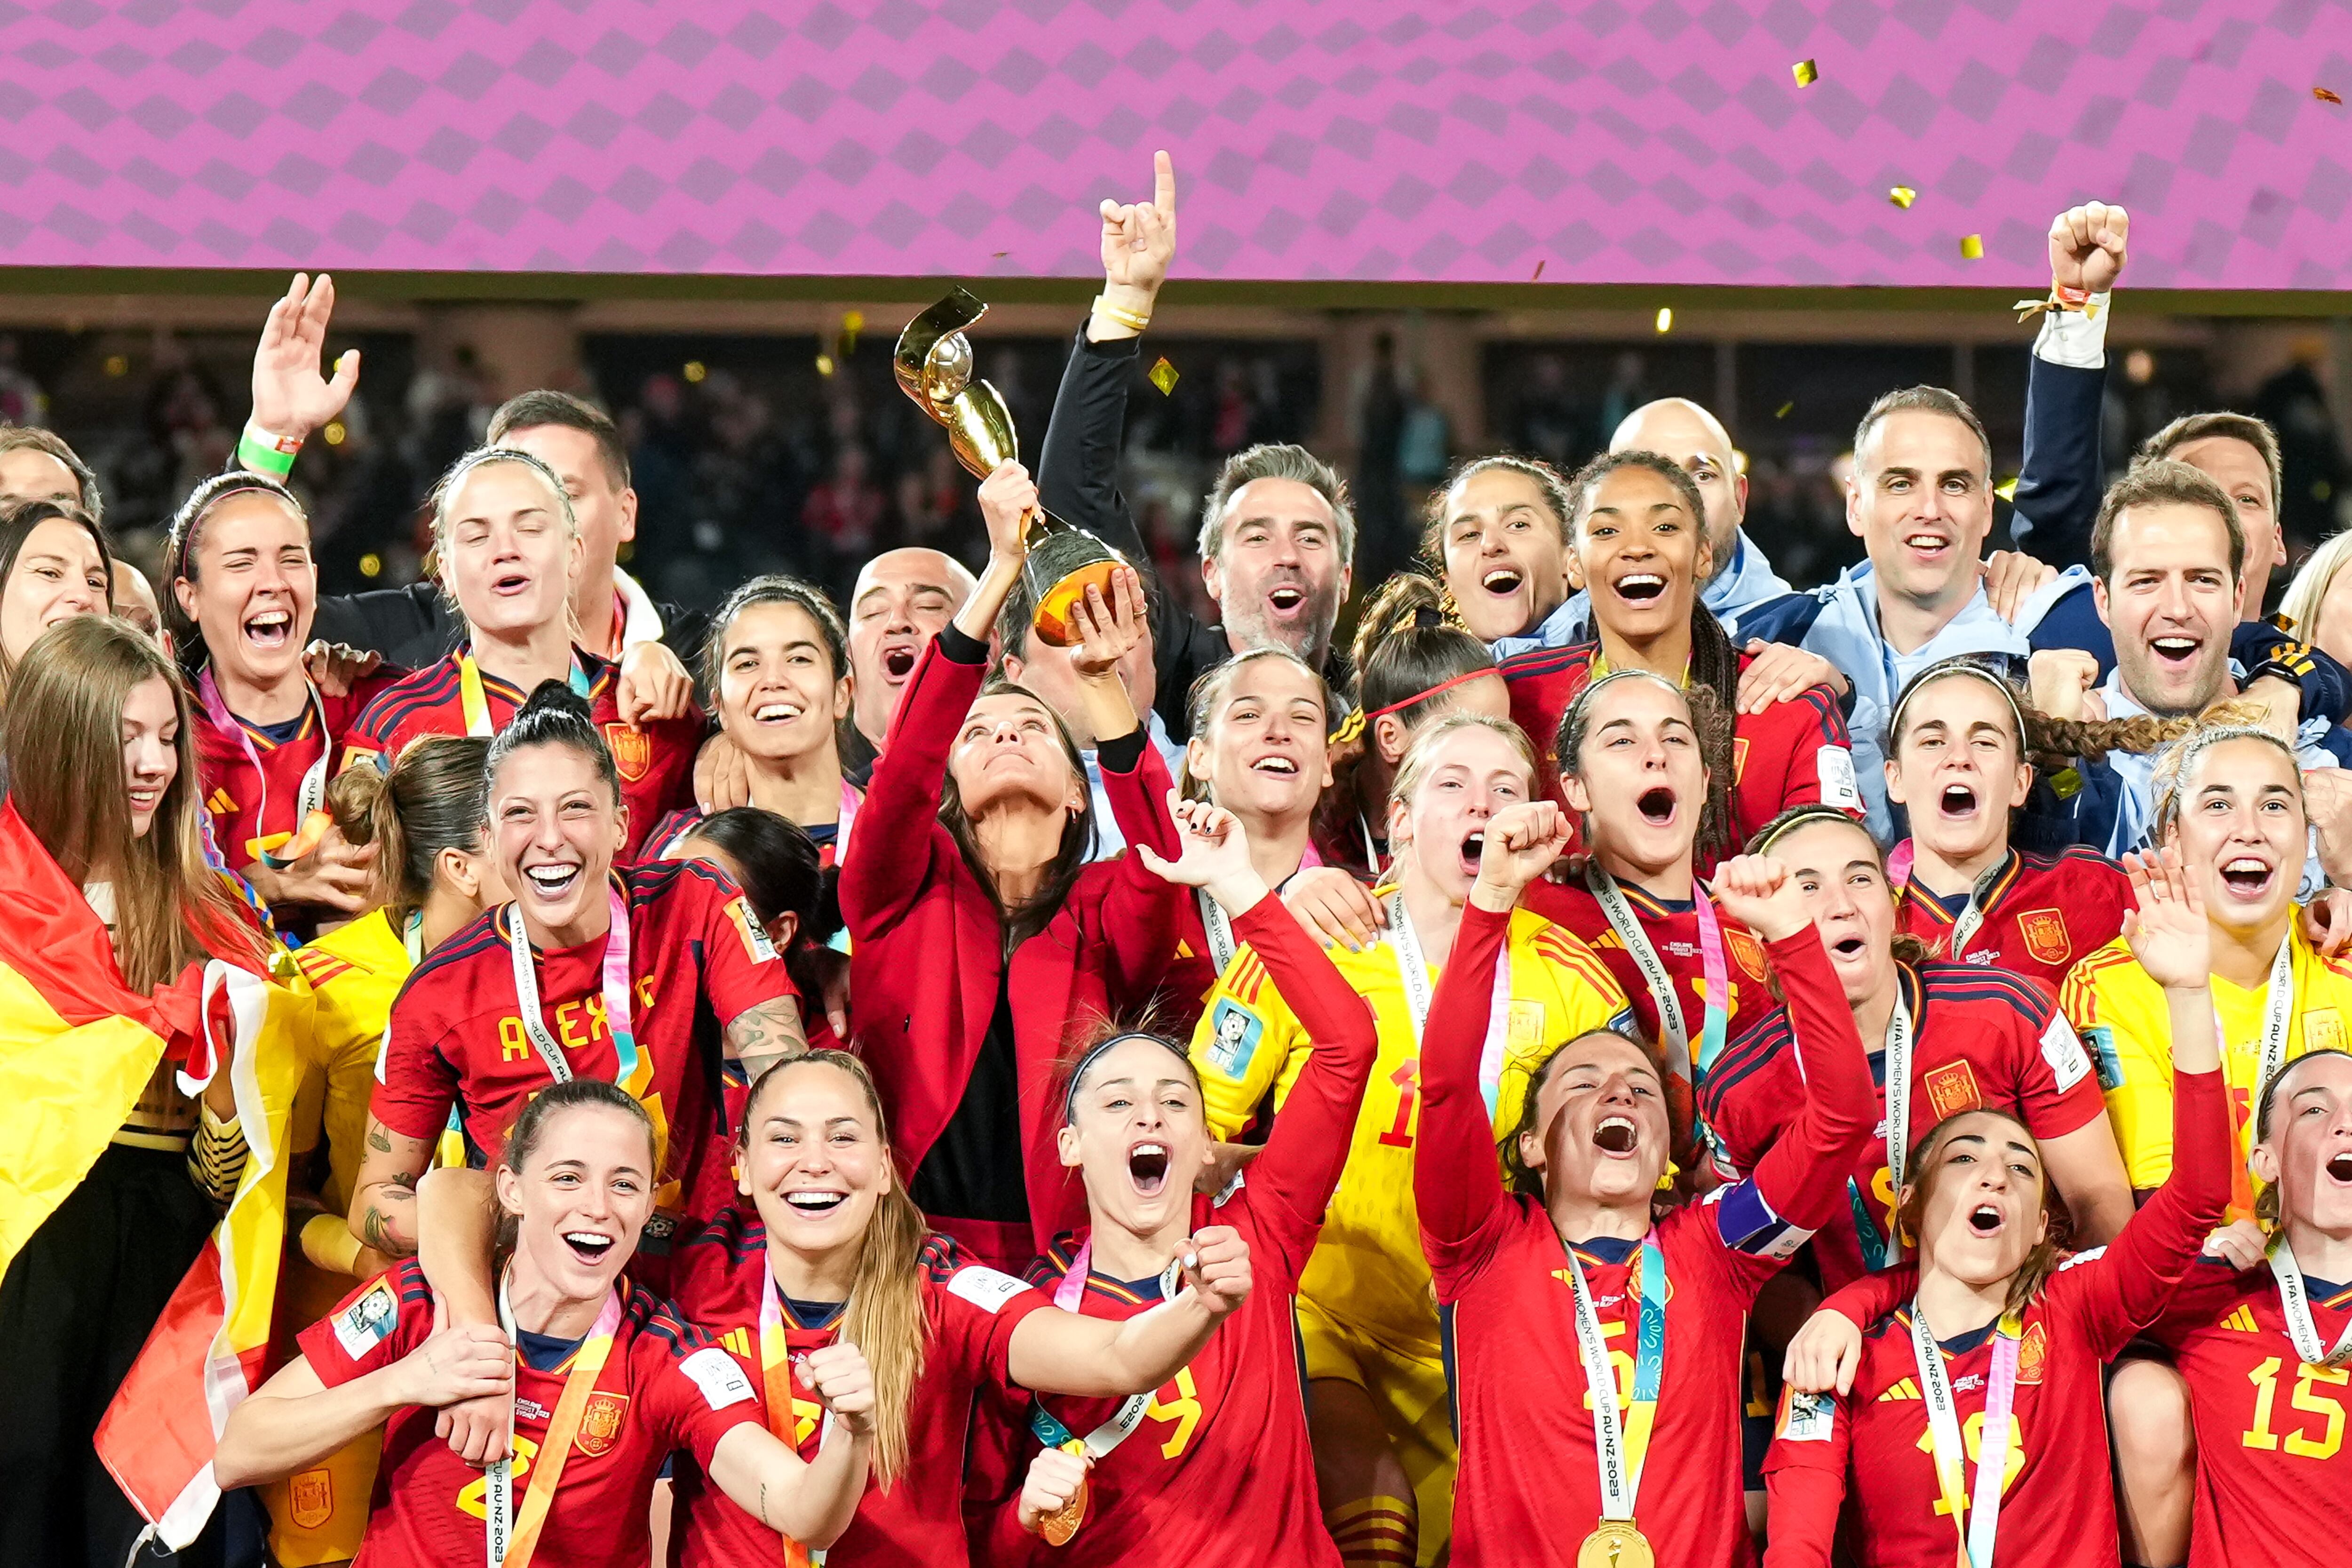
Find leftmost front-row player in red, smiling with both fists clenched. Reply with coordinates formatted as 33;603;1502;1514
214;1077;875;1568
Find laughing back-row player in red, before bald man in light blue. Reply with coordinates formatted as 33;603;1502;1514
1503;451;1860;870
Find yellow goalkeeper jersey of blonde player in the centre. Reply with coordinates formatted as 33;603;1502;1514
1192;910;1635;1354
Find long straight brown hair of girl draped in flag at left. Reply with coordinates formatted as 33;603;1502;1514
7;616;261;995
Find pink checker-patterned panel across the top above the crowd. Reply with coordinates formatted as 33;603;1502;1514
0;0;2352;289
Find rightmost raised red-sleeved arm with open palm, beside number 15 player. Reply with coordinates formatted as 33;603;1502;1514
2084;849;2232;1354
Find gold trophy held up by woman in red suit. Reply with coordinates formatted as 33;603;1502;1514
891;289;1127;649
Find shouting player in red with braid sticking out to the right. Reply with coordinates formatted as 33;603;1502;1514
1886;653;2147;990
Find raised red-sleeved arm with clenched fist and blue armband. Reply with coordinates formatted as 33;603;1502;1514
1712;856;1879;1229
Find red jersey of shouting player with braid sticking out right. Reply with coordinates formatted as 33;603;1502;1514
1896;846;2133;990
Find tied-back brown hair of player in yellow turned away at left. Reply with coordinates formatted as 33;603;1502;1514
327;736;489;926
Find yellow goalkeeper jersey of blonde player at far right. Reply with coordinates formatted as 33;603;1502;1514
2058;917;2352;1220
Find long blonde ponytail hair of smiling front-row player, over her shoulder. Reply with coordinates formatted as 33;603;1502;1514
736;1051;931;1490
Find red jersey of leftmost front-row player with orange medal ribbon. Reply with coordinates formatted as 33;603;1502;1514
301;1258;753;1568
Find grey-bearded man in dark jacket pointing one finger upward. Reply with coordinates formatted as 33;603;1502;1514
1037;153;1355;743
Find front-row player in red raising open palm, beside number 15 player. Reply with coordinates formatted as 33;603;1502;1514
1764;849;2230;1568
